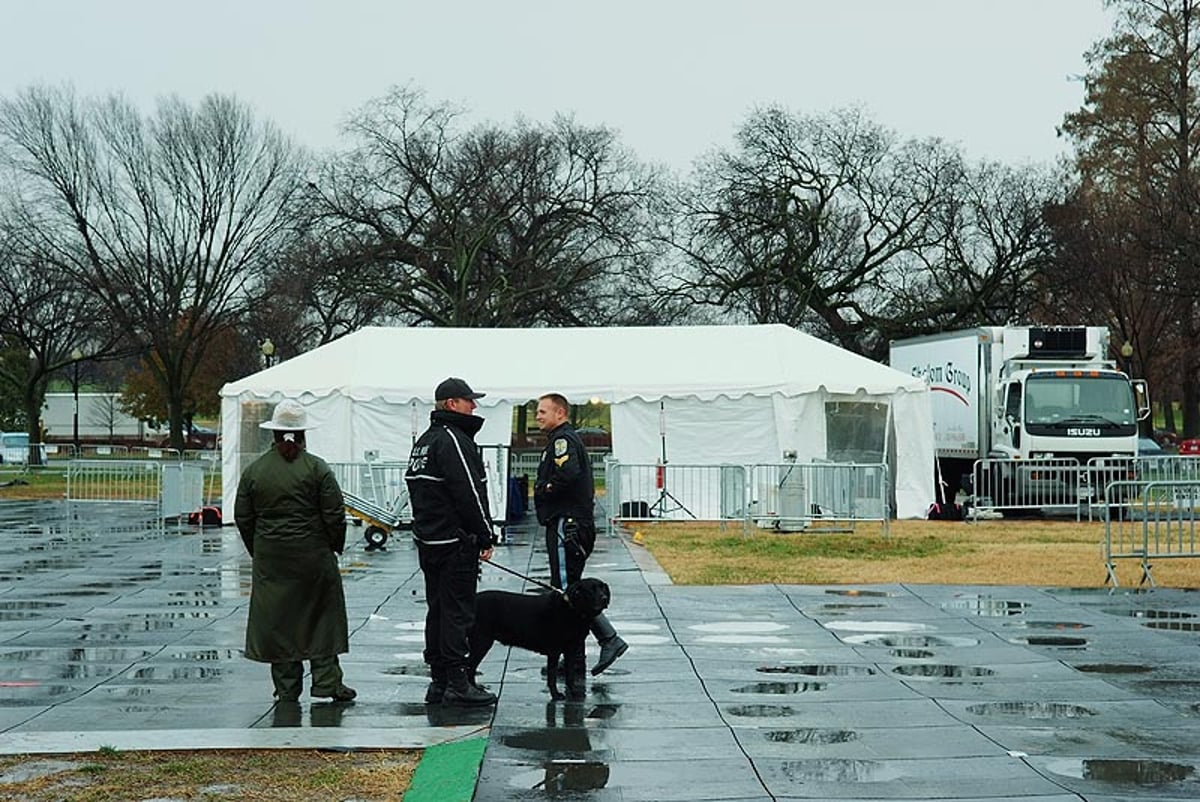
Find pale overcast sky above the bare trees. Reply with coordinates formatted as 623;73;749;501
0;0;1111;168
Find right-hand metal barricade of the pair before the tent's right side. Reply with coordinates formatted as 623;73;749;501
746;462;890;533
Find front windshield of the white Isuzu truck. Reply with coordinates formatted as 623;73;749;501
1025;372;1136;425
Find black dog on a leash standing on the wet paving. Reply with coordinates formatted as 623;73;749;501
469;579;610;700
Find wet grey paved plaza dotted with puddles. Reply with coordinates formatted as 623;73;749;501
0;502;1200;802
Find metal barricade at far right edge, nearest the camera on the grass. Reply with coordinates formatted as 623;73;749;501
1104;479;1200;589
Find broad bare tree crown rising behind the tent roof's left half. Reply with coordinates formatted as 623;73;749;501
314;90;656;327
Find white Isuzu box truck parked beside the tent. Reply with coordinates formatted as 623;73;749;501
889;327;1150;505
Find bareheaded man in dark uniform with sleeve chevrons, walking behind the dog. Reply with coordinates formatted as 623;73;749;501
534;393;629;695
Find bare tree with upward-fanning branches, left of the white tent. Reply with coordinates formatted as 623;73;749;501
0;88;300;447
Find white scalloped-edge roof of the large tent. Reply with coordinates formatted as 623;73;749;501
221;325;924;406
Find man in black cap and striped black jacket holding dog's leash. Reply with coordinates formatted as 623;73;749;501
404;378;496;705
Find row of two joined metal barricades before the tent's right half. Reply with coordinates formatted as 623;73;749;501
606;460;890;531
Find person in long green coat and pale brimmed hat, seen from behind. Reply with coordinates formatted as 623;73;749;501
234;401;356;702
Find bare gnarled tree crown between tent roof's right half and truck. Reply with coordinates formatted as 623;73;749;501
674;108;1045;358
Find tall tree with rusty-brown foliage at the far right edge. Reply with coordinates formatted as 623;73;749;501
1062;0;1200;437
